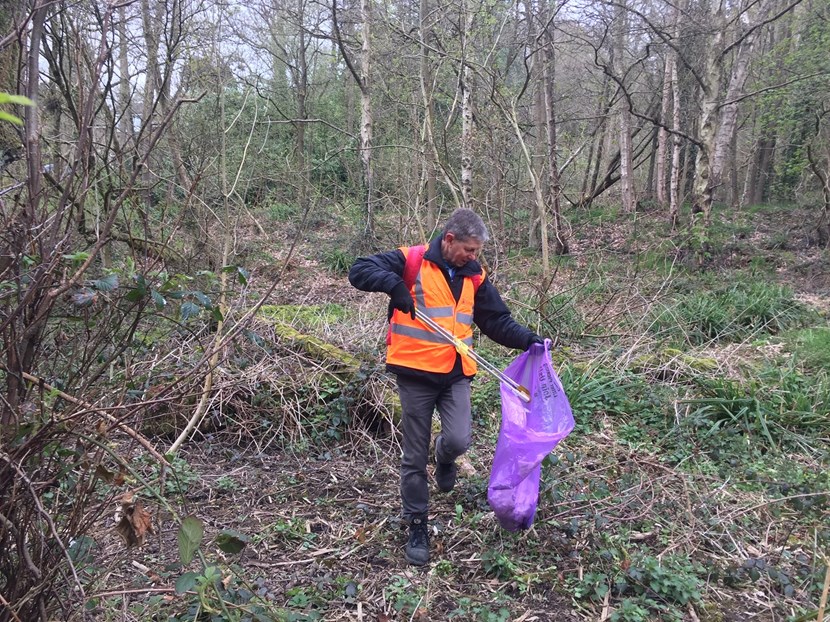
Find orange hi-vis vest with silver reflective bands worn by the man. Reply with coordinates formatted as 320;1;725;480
386;246;483;376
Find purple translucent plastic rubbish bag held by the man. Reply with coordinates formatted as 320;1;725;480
487;339;574;531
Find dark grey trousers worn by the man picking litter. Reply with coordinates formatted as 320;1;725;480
398;376;472;520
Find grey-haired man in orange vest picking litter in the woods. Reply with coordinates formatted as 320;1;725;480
349;209;542;566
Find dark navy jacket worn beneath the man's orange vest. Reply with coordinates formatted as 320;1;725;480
349;236;538;385
